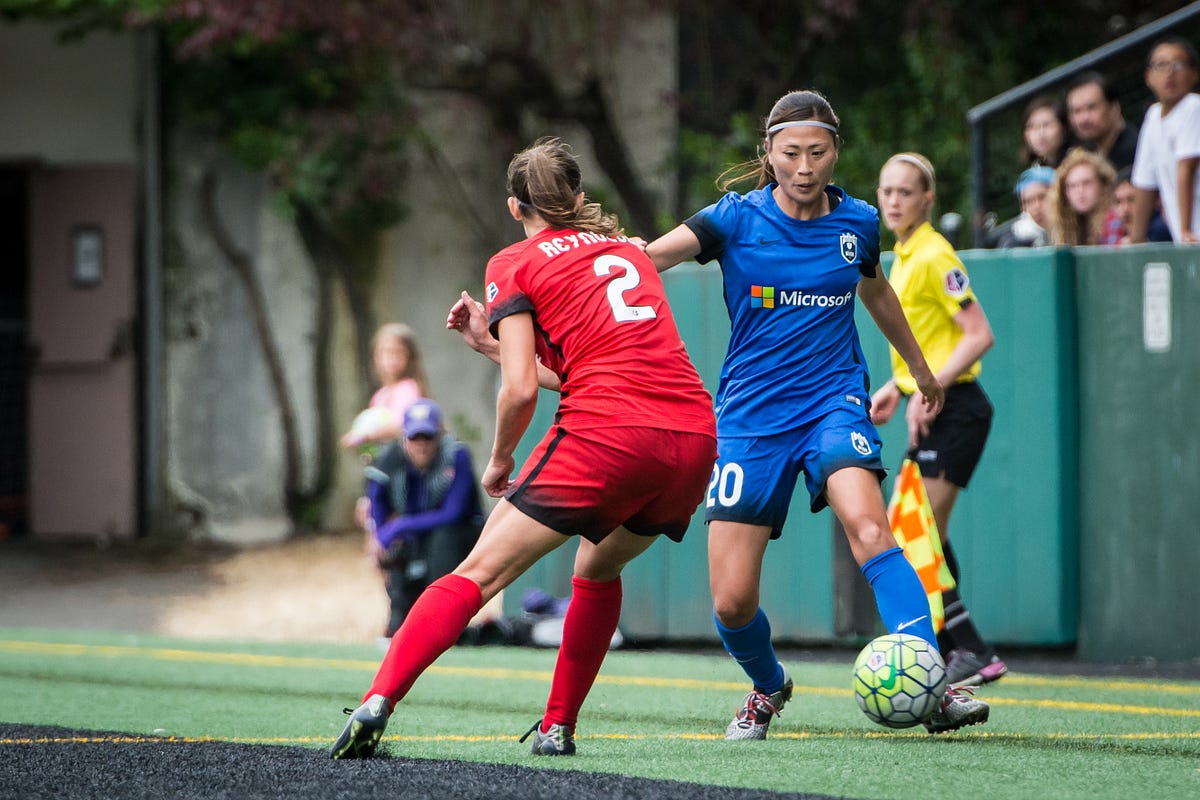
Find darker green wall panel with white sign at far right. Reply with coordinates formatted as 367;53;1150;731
1076;245;1200;661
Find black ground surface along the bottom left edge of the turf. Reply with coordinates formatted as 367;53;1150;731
0;723;849;800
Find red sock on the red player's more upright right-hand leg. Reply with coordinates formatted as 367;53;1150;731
542;577;622;730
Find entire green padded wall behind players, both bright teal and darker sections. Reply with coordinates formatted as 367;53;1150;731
489;245;1200;661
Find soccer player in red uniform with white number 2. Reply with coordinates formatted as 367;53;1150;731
331;139;716;758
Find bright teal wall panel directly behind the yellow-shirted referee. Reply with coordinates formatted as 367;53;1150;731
858;248;1078;645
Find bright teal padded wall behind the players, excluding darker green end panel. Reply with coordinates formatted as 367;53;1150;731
505;249;1078;644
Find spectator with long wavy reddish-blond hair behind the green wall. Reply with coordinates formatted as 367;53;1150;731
1050;148;1116;246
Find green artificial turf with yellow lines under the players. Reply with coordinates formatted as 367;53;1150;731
0;628;1200;800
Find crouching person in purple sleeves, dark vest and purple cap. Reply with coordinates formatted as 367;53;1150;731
366;399;484;637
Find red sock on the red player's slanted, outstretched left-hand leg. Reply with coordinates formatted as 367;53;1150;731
362;573;484;706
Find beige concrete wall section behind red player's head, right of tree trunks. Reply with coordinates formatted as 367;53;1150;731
376;4;678;489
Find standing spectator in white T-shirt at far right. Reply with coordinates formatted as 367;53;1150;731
1129;36;1200;245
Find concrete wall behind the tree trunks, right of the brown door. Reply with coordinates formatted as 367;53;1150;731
164;4;676;541
